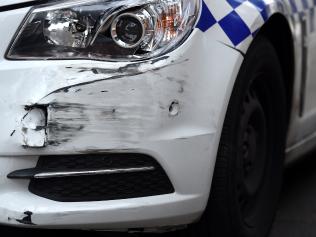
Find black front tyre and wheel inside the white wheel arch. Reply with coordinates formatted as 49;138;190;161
187;37;286;237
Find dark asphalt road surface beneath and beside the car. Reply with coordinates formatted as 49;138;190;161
0;152;316;237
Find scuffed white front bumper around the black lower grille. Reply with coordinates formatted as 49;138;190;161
0;6;242;229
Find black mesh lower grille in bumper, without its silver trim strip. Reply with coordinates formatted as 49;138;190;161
29;154;174;202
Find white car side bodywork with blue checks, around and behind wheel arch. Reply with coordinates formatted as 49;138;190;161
198;0;316;161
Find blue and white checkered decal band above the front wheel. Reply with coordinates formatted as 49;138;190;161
197;0;316;47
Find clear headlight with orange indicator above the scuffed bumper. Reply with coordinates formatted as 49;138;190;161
7;0;200;61
